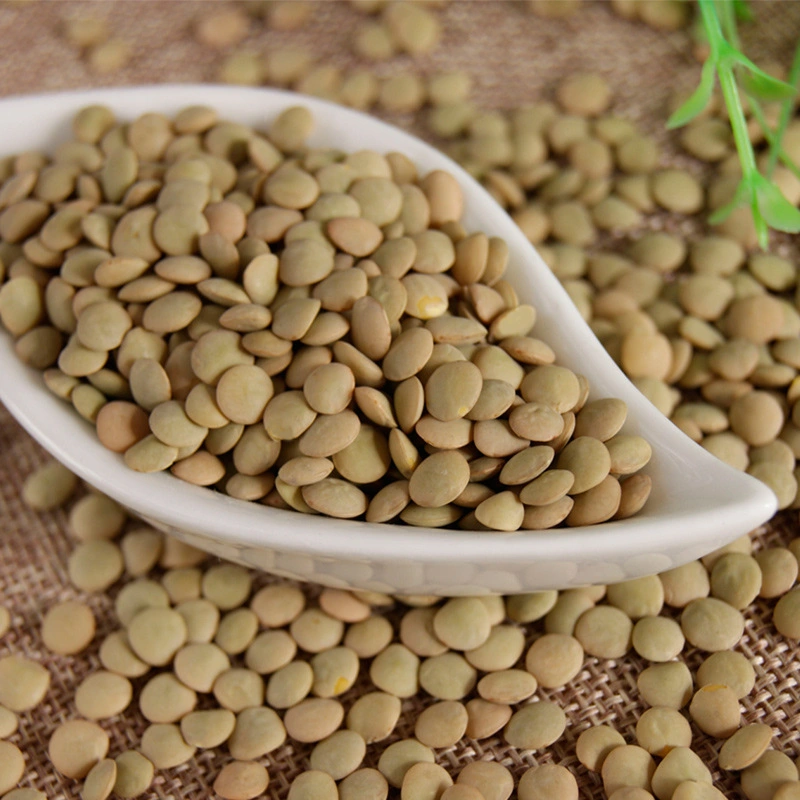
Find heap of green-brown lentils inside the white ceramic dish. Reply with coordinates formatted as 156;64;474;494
0;106;651;531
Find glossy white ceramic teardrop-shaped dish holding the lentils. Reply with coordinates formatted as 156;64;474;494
0;85;776;595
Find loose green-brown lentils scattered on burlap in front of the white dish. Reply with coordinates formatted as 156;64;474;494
0;468;800;800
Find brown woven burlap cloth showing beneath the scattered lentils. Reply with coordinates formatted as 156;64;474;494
0;0;800;800
